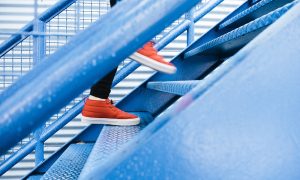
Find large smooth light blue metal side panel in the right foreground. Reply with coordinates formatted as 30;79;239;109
87;4;300;179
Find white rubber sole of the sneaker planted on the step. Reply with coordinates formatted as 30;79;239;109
81;116;140;126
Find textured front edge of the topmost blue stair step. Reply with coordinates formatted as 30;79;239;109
219;0;293;29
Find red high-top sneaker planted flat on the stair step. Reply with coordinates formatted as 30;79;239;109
81;99;140;126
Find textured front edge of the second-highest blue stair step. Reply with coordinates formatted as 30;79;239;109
184;1;298;58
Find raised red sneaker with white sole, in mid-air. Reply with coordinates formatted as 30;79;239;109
130;41;176;74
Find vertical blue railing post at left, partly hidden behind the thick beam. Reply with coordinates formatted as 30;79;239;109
33;0;46;166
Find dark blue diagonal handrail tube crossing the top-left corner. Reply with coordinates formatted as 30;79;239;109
0;0;76;57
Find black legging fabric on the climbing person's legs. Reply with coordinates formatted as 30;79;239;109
90;0;117;99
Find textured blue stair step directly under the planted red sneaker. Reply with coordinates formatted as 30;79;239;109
80;112;153;179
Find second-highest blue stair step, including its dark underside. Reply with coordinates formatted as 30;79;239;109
184;1;298;58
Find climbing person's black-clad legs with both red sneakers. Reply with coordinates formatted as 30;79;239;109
82;0;176;125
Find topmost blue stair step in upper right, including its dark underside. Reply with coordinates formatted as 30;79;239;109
219;0;293;29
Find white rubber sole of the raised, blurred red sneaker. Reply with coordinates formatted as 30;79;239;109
130;52;176;74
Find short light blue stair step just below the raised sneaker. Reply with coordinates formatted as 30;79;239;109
147;80;200;96
